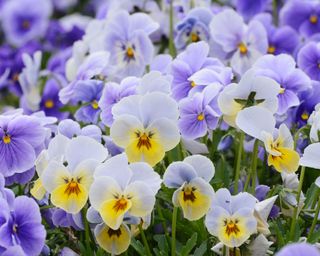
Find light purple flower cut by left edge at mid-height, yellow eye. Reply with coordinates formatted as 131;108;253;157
0;115;46;177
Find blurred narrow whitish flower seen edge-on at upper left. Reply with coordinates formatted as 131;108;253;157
19;51;42;111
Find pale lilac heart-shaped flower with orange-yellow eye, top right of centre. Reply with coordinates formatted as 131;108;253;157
210;10;268;75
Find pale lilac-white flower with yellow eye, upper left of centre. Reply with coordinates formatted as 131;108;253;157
104;11;159;79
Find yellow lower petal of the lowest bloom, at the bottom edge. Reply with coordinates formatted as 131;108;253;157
95;225;131;255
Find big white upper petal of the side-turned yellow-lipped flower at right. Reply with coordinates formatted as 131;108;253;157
236;106;276;140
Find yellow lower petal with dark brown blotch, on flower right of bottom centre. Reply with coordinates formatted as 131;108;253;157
178;186;211;221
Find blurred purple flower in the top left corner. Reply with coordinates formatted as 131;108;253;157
1;0;52;46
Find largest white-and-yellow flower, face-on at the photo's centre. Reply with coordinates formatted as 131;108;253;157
110;92;180;166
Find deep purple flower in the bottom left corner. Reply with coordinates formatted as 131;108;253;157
0;196;46;256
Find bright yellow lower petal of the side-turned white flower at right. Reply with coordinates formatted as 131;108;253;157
268;147;300;173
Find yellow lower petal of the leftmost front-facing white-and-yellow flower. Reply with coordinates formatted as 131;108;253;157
51;183;88;214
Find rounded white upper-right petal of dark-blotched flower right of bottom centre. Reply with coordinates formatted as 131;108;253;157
183;155;215;182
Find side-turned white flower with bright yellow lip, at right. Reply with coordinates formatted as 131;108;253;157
236;106;300;173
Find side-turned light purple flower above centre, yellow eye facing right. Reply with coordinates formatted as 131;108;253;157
171;41;222;101
